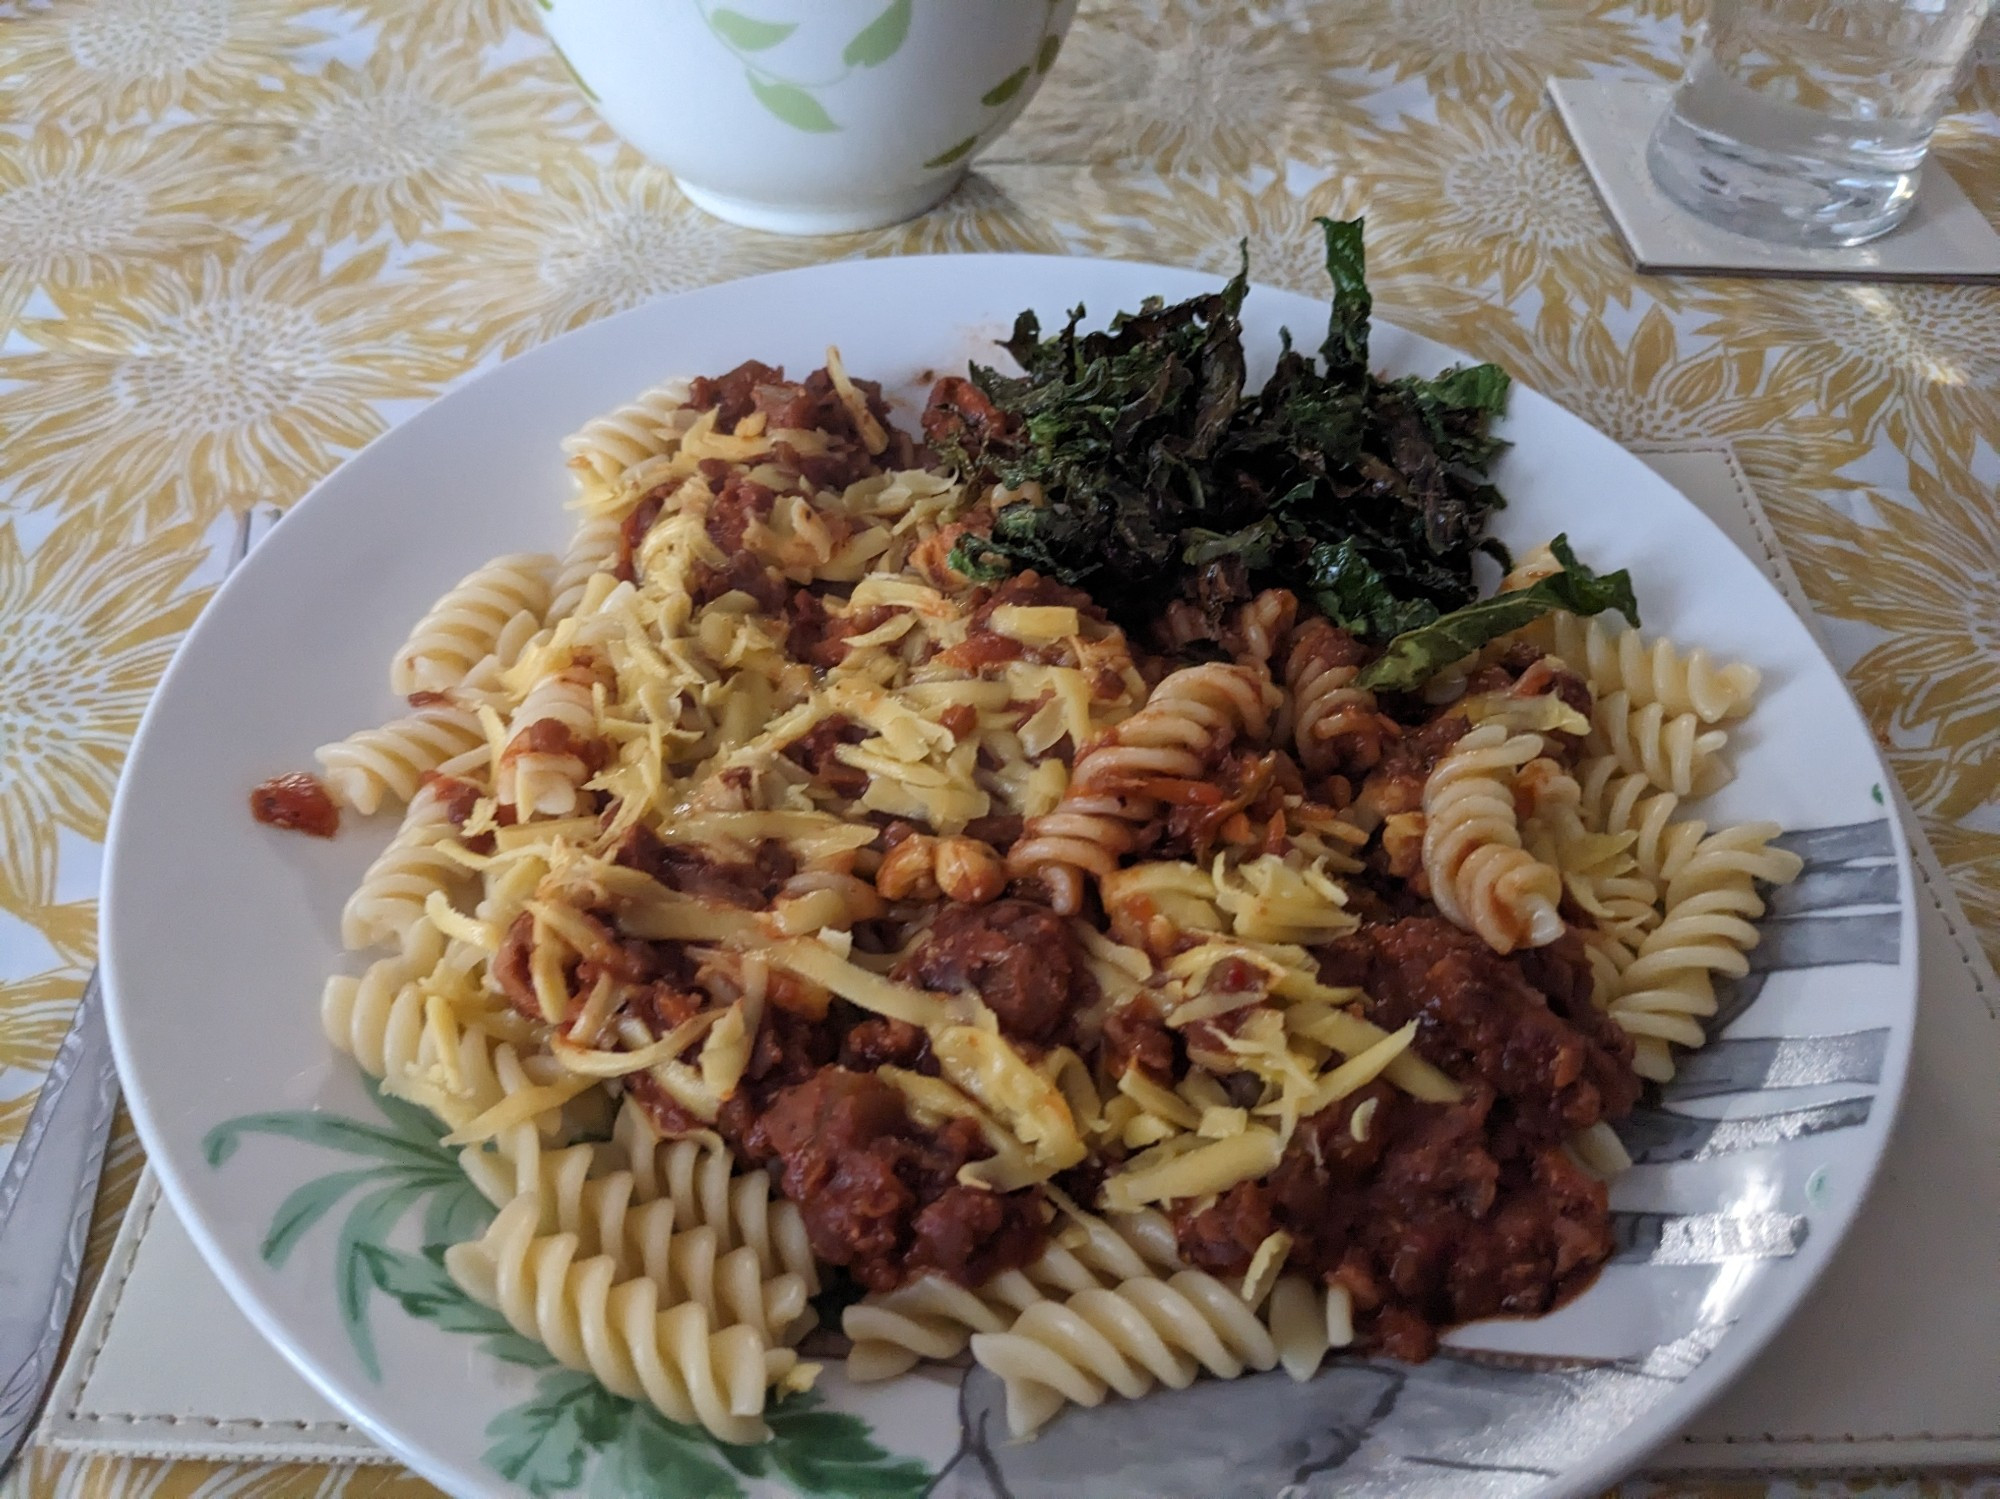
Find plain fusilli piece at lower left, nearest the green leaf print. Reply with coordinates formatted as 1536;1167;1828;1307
444;1193;780;1443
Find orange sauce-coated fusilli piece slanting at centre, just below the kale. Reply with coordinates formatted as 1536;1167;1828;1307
1008;664;1278;915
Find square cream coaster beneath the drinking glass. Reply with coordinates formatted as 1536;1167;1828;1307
1548;78;2000;282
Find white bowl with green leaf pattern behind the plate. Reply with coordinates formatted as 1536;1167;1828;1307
542;0;1076;234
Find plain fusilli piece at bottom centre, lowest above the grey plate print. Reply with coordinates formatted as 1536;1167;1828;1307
972;1269;1278;1437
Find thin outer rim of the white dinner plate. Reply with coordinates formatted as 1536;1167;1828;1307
98;252;1922;1499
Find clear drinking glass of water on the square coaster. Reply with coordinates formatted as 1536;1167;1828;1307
1646;0;1994;246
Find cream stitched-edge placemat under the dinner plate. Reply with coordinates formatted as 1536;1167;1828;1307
42;444;2000;1471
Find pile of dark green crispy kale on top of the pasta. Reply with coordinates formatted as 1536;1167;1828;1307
924;220;1544;642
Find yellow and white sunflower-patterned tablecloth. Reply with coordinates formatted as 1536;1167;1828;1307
0;0;2000;1497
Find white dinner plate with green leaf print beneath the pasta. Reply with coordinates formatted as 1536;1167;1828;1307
102;256;1916;1499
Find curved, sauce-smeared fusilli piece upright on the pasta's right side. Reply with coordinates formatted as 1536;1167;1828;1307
1424;724;1562;953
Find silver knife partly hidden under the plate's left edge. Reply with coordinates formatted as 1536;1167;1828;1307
0;506;282;1473
